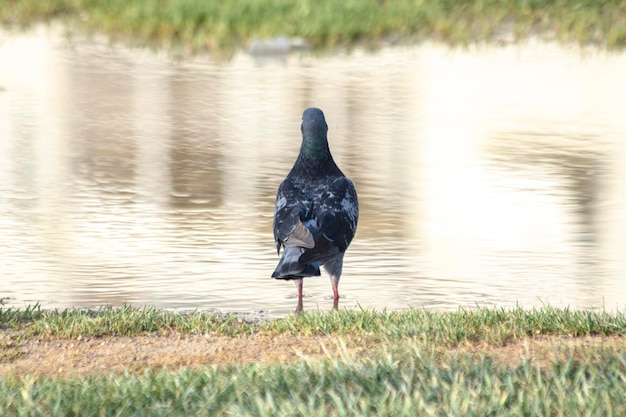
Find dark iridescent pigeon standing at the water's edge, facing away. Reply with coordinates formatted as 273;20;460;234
272;108;359;314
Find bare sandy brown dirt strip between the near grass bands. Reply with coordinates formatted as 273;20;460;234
0;333;626;376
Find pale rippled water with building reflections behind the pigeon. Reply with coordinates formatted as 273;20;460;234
0;28;626;316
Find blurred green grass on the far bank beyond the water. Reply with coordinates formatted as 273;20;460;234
0;0;626;51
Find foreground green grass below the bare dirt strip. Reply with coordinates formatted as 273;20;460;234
0;346;626;417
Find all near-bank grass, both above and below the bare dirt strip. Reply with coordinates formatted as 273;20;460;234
0;306;626;416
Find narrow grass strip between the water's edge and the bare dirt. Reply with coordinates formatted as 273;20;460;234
0;305;626;345
